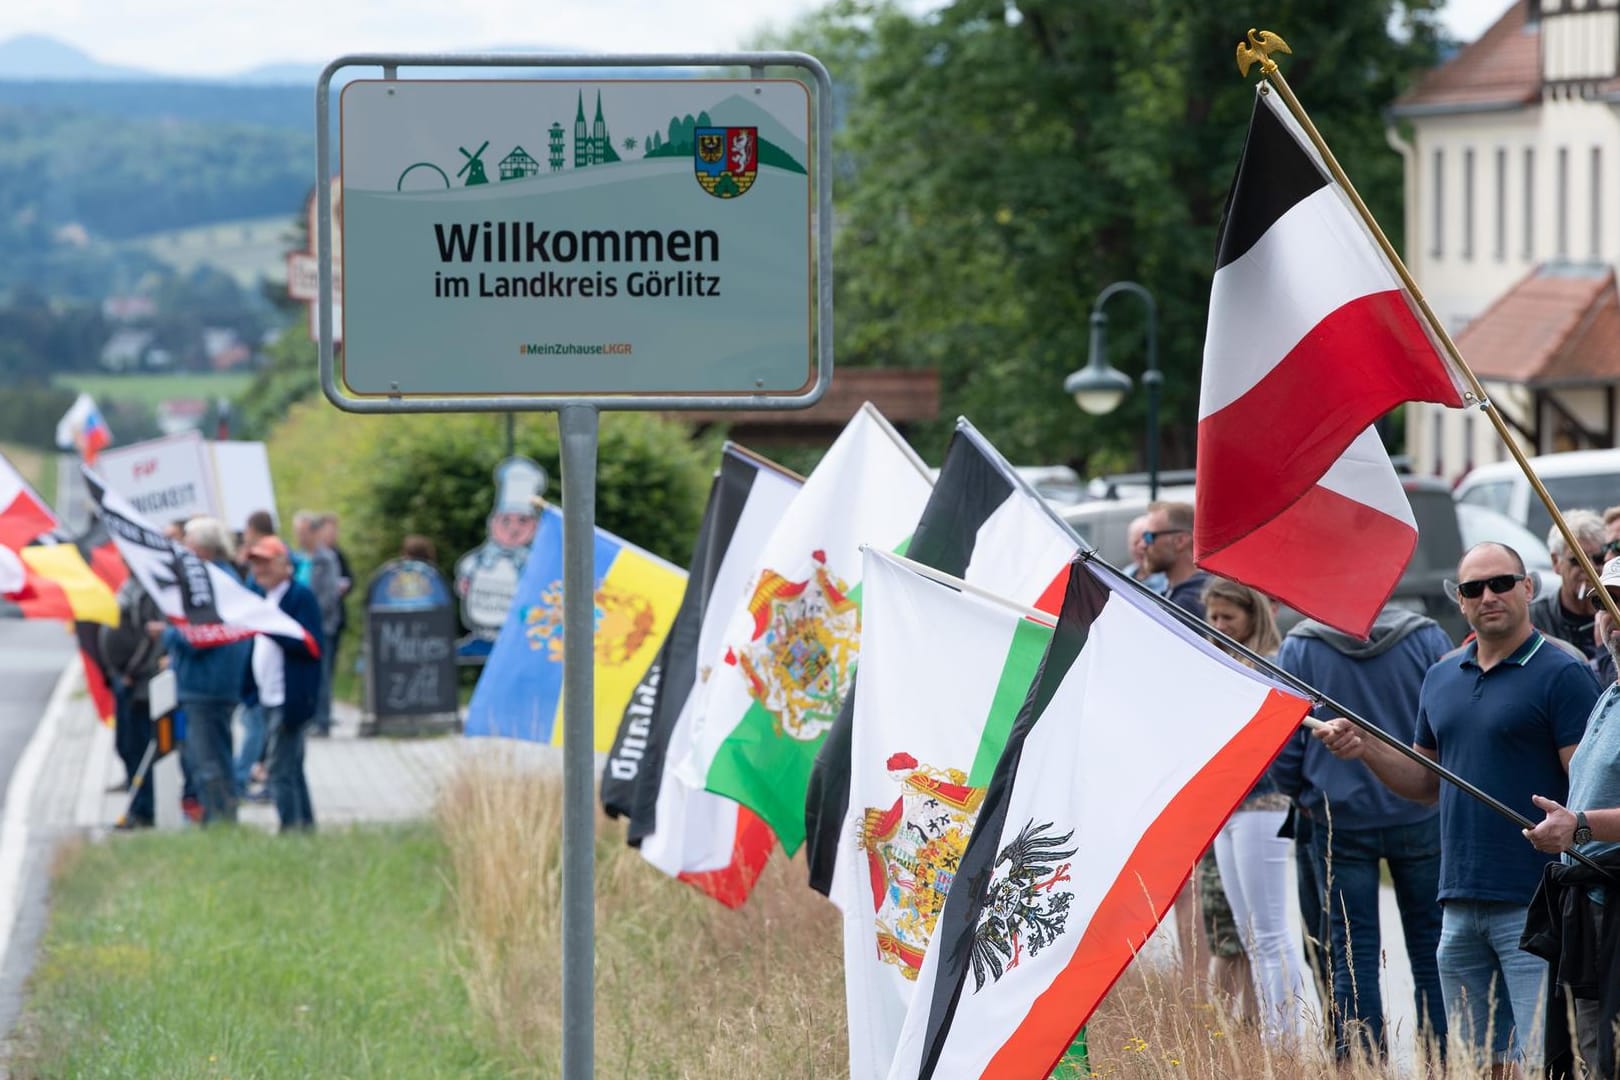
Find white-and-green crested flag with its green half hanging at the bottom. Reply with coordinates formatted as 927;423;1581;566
682;403;932;853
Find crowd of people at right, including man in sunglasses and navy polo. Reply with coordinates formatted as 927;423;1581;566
1129;502;1620;1077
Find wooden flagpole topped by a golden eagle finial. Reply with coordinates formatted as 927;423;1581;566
1238;29;1620;641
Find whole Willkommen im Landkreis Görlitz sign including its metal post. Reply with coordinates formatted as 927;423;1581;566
316;52;833;1080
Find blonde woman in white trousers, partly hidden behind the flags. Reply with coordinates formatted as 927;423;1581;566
1204;578;1312;1044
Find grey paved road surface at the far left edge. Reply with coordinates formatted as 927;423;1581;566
0;619;78;1031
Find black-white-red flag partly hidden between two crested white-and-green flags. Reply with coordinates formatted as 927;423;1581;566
805;419;1079;904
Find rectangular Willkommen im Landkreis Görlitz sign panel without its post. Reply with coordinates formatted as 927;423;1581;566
334;66;831;411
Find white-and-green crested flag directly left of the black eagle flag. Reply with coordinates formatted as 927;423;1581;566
831;553;1068;1080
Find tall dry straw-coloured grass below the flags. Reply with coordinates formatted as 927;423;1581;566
439;759;1522;1080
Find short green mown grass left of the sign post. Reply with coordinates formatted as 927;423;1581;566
8;824;505;1080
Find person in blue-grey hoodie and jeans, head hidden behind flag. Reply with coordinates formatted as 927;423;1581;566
1270;607;1453;1059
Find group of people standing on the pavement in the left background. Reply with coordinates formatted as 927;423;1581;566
100;510;352;831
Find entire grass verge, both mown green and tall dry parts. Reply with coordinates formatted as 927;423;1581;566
8;759;1487;1080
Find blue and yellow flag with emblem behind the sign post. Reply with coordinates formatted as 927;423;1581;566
467;507;687;751
